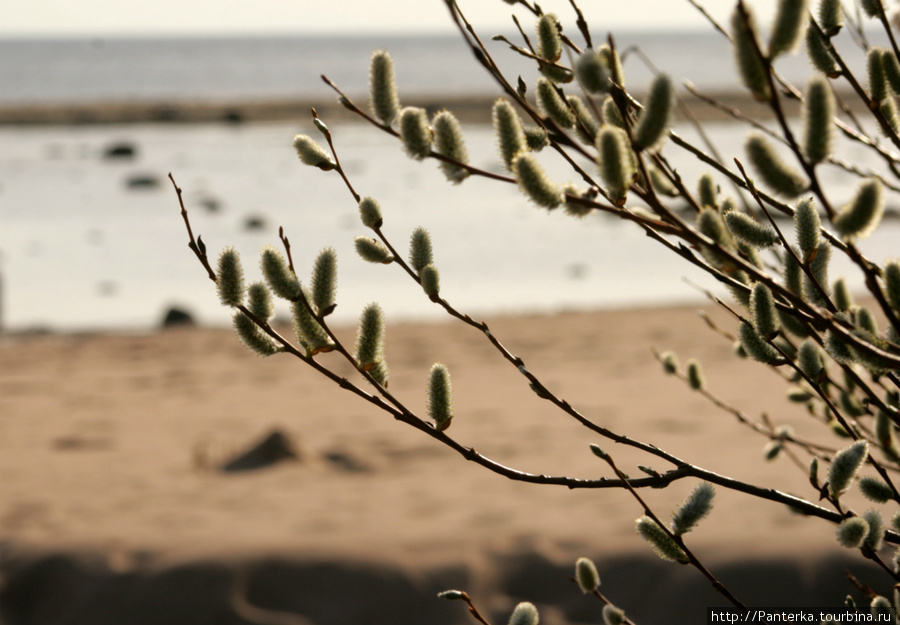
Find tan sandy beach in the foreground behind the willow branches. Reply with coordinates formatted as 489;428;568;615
0;307;887;623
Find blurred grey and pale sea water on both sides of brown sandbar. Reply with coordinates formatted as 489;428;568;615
0;30;900;332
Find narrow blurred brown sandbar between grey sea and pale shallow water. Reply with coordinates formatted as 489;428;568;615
0;91;828;126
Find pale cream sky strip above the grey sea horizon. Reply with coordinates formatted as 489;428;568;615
0;0;775;37
